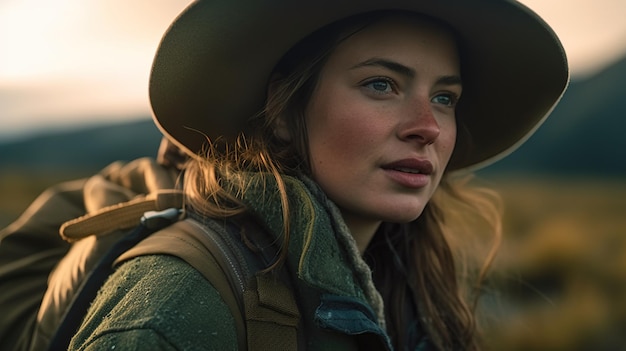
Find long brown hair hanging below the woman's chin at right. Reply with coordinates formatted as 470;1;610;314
364;175;501;350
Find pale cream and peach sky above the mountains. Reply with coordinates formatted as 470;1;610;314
0;0;626;140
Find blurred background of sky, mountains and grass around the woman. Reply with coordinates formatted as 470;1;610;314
0;0;626;351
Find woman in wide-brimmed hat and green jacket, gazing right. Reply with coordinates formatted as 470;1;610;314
71;0;568;350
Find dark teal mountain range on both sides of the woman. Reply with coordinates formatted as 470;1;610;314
0;57;626;180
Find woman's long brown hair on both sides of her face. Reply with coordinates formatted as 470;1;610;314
185;13;499;350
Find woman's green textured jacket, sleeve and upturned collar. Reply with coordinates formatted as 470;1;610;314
71;177;398;350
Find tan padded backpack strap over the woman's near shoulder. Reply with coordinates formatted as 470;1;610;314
115;218;300;350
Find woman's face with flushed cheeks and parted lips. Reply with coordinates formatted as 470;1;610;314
305;16;461;230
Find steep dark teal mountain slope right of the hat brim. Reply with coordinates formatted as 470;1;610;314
478;57;626;180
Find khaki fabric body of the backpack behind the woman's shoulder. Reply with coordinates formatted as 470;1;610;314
0;158;179;350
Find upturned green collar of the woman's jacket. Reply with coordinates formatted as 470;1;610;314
242;174;385;329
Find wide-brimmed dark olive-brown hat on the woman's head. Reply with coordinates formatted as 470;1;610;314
150;0;569;170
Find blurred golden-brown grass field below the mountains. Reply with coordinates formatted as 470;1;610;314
0;172;626;351
